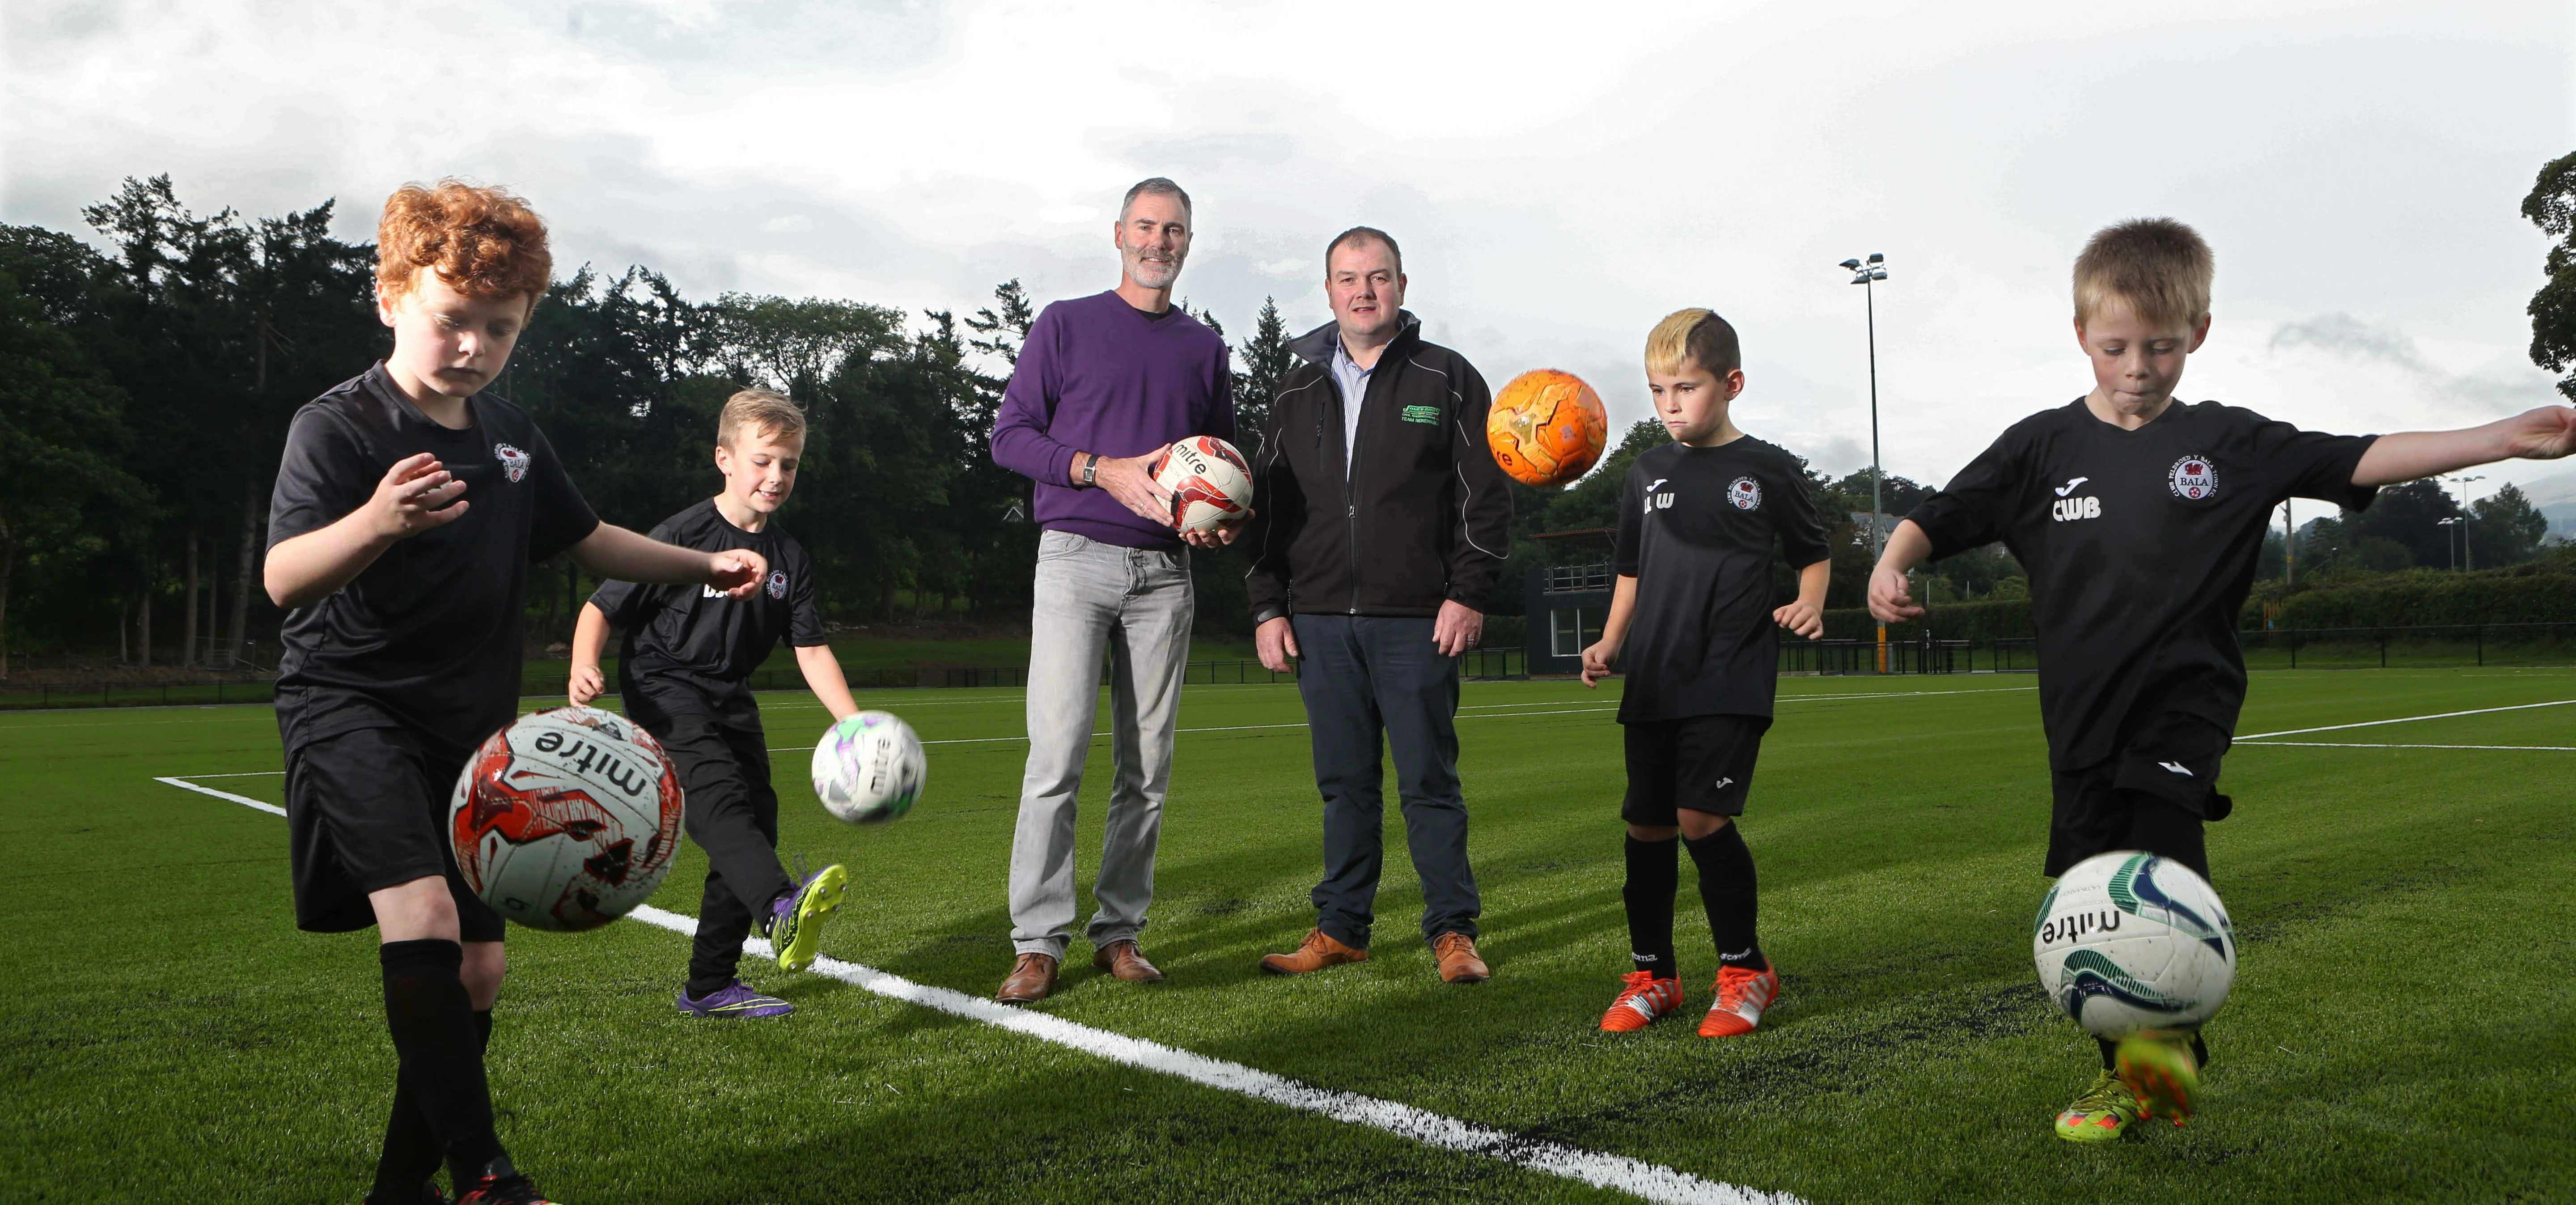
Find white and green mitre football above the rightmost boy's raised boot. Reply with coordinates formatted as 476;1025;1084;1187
2030;852;2236;1040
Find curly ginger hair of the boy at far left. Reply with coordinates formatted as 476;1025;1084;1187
376;180;554;309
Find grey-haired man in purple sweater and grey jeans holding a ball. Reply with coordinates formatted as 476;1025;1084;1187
992;175;1234;1004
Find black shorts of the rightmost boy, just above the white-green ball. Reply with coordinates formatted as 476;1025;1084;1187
2040;713;2236;878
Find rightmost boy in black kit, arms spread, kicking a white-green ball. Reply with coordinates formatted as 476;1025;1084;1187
1870;219;2576;1141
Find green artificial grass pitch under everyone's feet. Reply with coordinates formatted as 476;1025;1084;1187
0;670;2576;1205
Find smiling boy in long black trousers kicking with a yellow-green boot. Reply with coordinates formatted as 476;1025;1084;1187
569;389;858;1017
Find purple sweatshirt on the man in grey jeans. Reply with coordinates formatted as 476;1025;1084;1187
992;291;1234;548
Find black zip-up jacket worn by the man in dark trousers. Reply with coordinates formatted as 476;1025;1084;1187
1241;312;1512;623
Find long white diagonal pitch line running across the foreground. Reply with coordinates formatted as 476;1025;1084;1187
155;775;1803;1205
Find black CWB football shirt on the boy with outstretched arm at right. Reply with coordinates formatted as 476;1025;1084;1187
1906;399;2377;770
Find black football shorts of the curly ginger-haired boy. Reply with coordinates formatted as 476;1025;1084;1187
286;729;502;942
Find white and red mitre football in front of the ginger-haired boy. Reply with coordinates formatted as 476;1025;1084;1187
448;708;680;929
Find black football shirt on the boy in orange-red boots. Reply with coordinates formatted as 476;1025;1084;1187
1615;435;1829;724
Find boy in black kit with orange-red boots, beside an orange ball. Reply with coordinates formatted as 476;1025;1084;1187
1584;309;1831;1038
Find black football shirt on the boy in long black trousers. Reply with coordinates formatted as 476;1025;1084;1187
590;500;827;695
